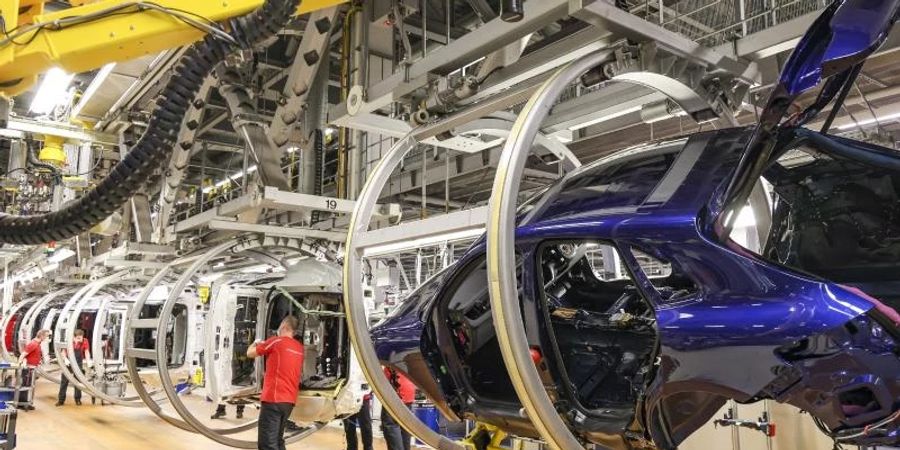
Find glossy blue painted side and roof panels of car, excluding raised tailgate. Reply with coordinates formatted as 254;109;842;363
372;129;900;448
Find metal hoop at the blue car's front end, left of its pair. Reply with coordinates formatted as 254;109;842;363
344;119;581;450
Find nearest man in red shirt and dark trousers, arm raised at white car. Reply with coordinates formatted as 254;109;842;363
247;316;303;450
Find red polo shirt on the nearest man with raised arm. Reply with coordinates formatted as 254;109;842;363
256;336;303;404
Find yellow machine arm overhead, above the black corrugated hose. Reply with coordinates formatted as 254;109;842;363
0;0;347;96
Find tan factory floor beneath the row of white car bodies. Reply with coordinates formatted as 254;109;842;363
16;380;385;450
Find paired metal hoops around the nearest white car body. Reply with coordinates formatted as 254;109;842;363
125;238;321;449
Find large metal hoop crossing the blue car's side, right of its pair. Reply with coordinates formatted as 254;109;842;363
486;50;705;450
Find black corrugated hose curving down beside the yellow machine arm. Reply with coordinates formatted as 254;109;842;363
0;0;300;245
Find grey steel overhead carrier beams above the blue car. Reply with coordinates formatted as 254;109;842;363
331;0;760;151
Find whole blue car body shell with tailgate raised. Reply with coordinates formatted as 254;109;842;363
372;0;900;449
